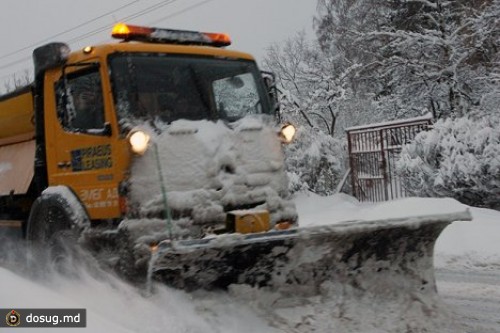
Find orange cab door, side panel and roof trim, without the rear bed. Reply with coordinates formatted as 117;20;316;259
40;43;253;219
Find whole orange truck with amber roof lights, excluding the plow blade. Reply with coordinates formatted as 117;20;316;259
0;24;296;245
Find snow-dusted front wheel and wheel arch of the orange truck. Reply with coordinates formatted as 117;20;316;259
26;186;90;270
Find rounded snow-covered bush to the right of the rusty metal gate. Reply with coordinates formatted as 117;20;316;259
397;117;500;208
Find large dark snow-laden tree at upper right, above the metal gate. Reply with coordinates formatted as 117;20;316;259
316;0;500;119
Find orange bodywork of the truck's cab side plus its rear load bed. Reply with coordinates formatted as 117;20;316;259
0;42;253;220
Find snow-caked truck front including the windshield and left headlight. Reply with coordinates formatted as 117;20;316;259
109;48;297;237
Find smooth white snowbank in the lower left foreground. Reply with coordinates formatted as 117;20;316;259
0;262;278;333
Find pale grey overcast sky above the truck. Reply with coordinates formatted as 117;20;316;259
0;0;316;87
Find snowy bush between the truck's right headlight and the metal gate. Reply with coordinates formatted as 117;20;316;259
285;127;347;195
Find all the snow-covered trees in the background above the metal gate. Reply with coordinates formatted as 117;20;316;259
265;0;500;196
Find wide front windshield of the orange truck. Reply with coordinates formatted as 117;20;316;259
109;53;271;128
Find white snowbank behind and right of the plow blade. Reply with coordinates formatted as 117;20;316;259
296;193;500;269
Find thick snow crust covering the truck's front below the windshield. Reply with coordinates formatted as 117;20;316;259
130;118;296;235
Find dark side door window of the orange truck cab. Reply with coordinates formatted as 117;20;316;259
56;69;104;132
